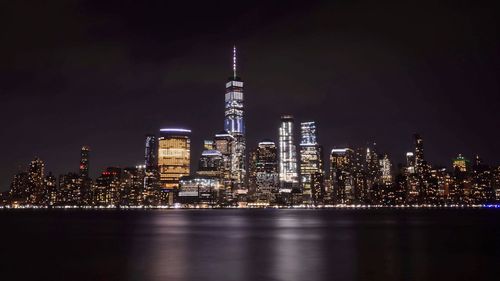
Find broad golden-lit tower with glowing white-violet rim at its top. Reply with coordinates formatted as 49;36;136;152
158;128;191;190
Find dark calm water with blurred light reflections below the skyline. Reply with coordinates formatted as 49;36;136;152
0;209;500;281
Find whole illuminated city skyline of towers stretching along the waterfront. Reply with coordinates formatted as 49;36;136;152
0;47;500;208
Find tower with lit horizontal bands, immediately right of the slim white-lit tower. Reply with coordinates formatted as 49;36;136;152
300;122;323;201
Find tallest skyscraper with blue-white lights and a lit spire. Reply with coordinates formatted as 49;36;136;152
224;47;247;193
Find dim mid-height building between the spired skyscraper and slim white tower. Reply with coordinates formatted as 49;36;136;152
250;140;279;202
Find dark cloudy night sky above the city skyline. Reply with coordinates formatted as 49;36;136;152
0;0;500;190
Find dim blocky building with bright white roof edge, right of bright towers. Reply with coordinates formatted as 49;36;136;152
330;148;355;204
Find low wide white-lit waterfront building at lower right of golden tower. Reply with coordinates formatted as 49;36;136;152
177;176;222;205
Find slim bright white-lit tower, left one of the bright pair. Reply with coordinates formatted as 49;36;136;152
279;115;299;193
